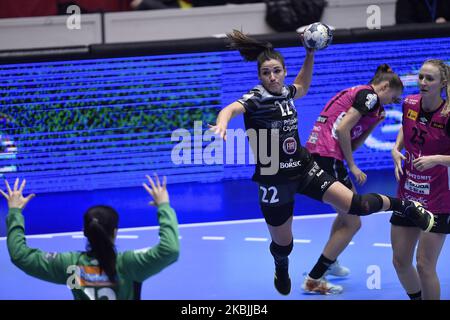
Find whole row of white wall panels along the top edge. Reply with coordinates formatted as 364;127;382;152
0;0;396;50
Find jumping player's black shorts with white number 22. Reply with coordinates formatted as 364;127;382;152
258;161;336;226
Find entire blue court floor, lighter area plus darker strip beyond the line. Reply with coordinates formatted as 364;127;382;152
0;170;450;300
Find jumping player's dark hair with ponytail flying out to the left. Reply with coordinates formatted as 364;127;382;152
227;30;286;72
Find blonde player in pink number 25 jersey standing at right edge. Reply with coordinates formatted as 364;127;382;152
391;60;450;300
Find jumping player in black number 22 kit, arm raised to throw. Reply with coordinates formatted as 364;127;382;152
211;30;433;294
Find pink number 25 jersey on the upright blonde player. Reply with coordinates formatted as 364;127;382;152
397;94;450;214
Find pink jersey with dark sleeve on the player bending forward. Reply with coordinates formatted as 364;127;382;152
305;85;384;161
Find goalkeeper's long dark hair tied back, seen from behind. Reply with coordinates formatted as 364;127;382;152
84;206;119;282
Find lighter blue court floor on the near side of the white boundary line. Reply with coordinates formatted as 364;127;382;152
0;213;450;300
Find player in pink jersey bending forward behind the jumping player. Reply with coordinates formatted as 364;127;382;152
304;64;403;292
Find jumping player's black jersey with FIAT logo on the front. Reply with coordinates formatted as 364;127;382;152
238;85;312;184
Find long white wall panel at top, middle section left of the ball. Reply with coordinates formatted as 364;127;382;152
105;3;274;43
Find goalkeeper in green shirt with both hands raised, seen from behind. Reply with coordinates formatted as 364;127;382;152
0;175;179;300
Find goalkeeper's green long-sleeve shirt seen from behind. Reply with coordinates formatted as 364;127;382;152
6;203;179;300
